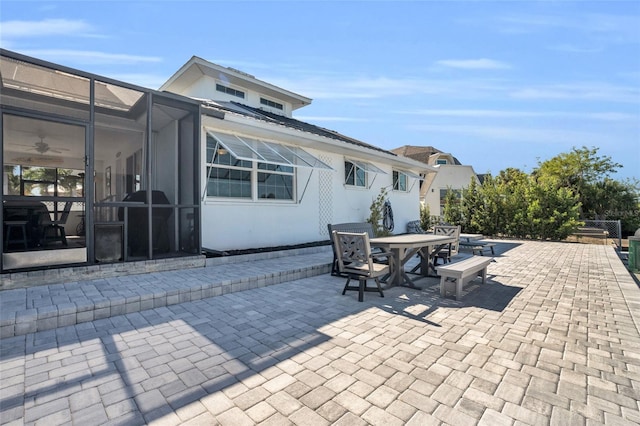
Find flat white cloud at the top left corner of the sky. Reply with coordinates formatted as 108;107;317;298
0;19;95;39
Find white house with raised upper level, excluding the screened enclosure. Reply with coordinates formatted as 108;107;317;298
160;56;436;251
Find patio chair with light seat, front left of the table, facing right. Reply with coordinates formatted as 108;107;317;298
332;231;391;302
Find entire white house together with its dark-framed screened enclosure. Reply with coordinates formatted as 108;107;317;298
0;49;435;278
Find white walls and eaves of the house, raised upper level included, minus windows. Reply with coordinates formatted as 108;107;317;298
161;57;430;251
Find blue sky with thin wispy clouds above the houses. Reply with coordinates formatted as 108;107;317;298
0;0;640;179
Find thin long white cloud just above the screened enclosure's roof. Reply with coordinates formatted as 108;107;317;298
16;49;162;65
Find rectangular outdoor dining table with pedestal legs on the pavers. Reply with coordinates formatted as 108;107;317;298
371;234;456;290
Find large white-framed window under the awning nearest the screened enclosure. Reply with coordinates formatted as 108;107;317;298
207;136;294;200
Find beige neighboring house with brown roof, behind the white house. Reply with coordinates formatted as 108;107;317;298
392;145;480;216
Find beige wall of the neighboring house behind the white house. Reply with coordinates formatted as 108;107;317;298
423;164;480;216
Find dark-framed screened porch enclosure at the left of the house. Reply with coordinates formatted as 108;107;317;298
0;51;200;271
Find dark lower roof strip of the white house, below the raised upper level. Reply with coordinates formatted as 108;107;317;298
202;101;397;156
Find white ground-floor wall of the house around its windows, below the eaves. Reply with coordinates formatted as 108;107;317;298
201;118;420;251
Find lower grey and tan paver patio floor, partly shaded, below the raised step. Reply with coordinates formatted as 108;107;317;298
0;241;640;426
